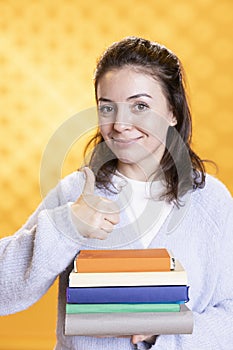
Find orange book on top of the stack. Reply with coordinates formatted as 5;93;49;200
74;248;175;273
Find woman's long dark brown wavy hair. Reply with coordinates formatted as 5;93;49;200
82;37;205;203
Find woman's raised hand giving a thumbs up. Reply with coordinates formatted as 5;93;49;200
71;167;119;239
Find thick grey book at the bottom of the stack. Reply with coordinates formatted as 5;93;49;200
65;304;193;336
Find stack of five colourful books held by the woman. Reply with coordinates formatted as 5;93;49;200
65;248;193;336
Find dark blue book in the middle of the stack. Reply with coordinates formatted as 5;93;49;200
66;285;189;304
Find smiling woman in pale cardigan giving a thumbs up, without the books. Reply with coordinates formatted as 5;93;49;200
0;37;233;350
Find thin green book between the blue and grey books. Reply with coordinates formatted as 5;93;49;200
66;303;180;314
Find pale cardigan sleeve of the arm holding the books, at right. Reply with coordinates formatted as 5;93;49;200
152;199;233;350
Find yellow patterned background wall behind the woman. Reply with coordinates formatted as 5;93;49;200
0;0;233;350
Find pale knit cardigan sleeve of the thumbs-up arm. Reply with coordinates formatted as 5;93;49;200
0;174;85;315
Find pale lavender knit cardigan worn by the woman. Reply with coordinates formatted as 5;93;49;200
0;172;233;350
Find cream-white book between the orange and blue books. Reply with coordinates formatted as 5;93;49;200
69;259;188;287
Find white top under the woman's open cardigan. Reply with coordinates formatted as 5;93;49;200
113;172;173;248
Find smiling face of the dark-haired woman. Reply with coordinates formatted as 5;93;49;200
97;67;176;175
